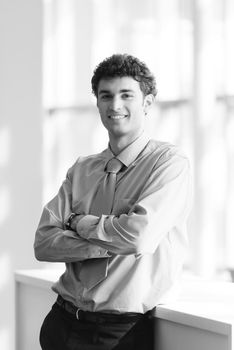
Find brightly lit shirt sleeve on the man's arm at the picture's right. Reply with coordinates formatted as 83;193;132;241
77;154;192;256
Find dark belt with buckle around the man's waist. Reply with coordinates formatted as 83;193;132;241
56;295;143;323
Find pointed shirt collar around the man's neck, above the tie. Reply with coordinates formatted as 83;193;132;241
105;132;150;167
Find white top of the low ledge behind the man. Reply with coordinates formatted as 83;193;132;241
15;269;234;335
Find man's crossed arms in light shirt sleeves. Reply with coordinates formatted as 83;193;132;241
34;154;191;263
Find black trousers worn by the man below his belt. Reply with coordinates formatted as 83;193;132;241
40;303;155;350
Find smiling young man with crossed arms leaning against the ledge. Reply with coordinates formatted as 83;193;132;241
34;55;191;350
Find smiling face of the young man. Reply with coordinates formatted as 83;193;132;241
97;77;152;142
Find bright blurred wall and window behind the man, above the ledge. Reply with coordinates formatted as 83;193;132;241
0;0;234;350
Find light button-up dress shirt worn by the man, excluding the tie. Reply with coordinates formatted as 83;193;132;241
34;134;191;313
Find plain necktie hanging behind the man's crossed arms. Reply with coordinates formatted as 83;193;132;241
79;158;123;289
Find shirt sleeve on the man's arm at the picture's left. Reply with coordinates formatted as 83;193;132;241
34;167;108;263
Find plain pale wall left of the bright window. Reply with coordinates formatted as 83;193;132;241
0;0;42;350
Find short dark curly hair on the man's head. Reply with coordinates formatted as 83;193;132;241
91;54;157;97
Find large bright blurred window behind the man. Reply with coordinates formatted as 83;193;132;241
44;0;234;279
